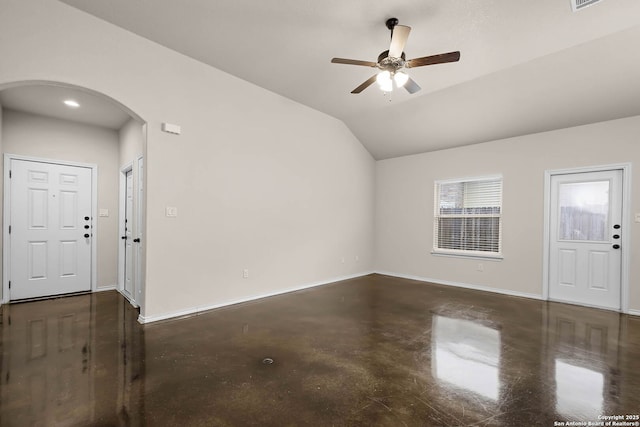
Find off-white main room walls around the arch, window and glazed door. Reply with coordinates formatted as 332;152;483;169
0;0;640;319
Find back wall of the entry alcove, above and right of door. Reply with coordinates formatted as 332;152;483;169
2;109;119;288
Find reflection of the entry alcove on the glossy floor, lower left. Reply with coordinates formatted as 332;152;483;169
0;293;143;426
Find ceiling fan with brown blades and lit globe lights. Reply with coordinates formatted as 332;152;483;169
331;18;460;94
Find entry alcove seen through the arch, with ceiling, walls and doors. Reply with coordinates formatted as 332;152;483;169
0;81;146;306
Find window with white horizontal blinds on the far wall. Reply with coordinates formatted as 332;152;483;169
433;176;502;257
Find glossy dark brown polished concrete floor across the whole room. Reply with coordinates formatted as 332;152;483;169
0;275;640;426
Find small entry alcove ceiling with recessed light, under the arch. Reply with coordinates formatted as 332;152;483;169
0;84;131;130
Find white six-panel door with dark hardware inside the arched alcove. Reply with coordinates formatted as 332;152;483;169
9;159;92;300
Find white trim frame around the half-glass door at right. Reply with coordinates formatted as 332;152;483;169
542;163;631;313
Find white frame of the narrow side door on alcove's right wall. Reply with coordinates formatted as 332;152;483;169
118;162;139;307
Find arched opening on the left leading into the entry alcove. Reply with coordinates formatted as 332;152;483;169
0;81;146;306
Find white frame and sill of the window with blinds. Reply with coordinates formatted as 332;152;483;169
431;175;504;261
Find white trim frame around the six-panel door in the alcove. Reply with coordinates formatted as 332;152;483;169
2;153;99;304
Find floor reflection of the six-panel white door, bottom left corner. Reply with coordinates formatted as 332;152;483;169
2;298;95;425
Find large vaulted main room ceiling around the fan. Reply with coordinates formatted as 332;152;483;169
48;0;640;159
